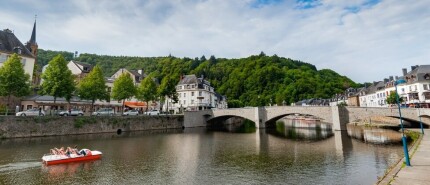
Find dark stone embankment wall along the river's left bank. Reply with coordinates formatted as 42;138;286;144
0;115;184;139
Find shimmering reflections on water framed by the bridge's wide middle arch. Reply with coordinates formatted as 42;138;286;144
267;119;333;141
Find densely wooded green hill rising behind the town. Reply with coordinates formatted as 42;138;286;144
38;49;357;106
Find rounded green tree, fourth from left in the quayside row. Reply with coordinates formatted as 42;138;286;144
112;73;136;113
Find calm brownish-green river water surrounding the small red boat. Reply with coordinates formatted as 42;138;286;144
0;122;402;184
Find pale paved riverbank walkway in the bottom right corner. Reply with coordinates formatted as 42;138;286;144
376;129;424;185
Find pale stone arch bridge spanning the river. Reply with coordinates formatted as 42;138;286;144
184;106;430;130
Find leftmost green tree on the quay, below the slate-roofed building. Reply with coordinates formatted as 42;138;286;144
0;54;30;114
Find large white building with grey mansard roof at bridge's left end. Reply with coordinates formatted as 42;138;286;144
163;75;227;113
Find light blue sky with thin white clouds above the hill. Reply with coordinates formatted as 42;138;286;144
0;0;430;82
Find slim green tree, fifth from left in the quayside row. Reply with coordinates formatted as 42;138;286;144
136;76;157;111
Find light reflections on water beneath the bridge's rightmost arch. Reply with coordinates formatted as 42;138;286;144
347;124;402;144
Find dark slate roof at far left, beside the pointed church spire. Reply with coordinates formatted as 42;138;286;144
0;29;36;58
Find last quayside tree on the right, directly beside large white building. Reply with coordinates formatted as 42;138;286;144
158;76;179;112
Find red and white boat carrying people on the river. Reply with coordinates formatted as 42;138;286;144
42;149;102;165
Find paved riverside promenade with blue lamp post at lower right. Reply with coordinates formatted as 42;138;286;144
389;129;430;185
